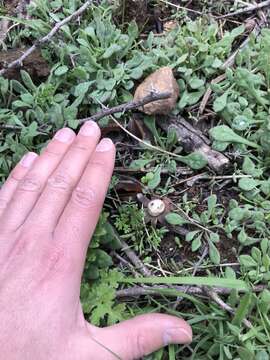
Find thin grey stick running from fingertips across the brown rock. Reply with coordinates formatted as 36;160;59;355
79;92;172;124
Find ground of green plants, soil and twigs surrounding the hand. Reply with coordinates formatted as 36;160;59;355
0;0;270;360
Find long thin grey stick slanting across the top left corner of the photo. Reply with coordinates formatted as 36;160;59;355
0;0;93;76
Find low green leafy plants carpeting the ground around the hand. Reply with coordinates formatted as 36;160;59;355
0;0;270;360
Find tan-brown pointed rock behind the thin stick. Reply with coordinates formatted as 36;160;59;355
134;66;179;115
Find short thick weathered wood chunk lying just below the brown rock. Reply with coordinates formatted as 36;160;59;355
158;116;229;173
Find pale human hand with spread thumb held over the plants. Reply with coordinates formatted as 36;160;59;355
0;122;192;360
